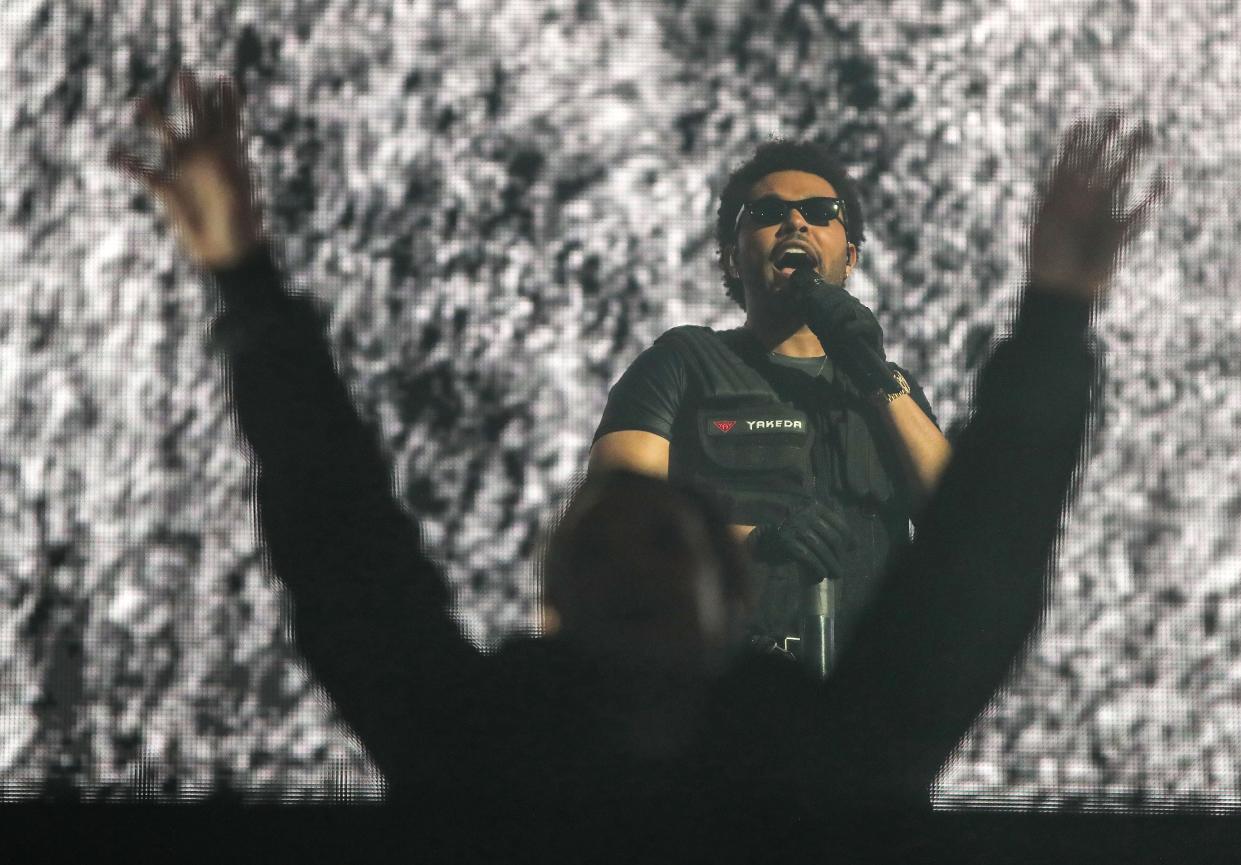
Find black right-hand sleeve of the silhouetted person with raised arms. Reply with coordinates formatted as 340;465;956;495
823;286;1097;803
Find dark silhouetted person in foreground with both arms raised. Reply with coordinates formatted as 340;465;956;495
115;73;1160;846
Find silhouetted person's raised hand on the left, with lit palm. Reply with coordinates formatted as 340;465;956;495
108;71;263;268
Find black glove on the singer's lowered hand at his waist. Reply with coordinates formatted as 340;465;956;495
747;501;858;583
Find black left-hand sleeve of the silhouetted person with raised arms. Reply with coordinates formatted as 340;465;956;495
212;245;475;787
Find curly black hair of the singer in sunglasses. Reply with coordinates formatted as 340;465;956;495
715;139;866;309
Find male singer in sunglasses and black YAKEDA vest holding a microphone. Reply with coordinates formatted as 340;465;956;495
591;141;951;654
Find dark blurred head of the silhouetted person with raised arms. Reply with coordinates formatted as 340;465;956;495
546;472;752;676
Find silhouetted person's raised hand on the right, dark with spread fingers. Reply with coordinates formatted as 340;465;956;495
1030;113;1167;302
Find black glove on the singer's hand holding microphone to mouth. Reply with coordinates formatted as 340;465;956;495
793;268;901;393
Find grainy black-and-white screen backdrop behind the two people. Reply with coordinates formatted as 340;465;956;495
0;0;1241;809
